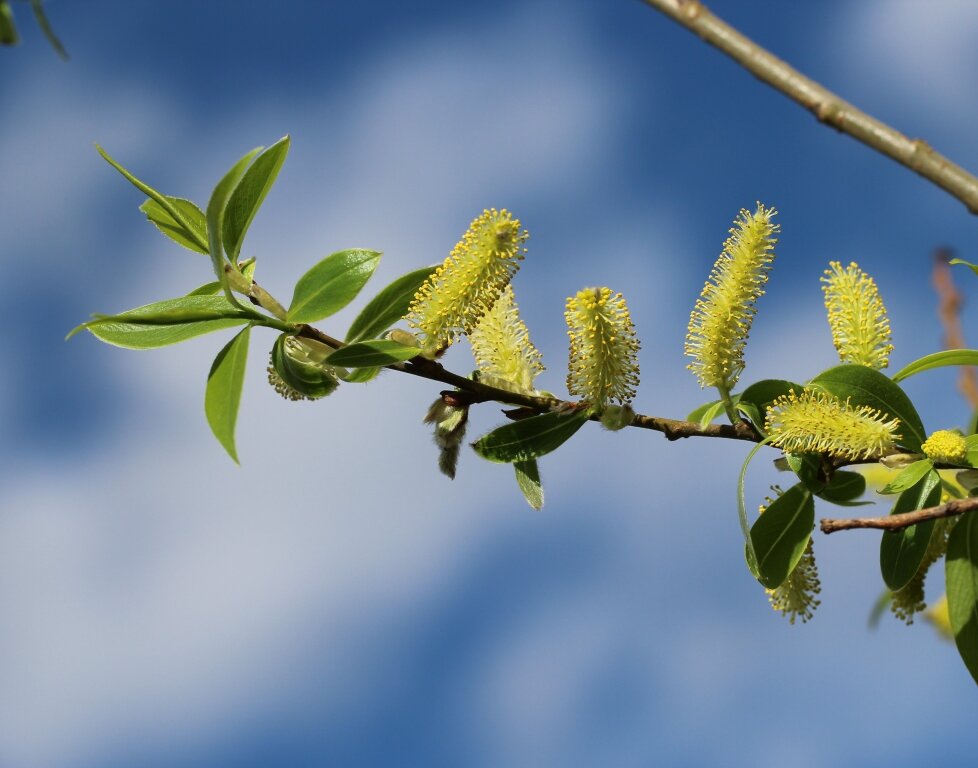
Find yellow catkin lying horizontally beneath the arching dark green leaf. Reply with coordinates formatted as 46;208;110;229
765;389;900;460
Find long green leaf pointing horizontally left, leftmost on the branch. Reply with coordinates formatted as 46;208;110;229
69;296;264;349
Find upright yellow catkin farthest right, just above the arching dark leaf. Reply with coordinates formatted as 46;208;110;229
822;261;893;369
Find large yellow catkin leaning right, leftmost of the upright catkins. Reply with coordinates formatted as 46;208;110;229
406;208;528;357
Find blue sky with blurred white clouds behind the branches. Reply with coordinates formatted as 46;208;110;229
0;0;978;768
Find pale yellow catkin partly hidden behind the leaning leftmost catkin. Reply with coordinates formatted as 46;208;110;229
469;285;543;393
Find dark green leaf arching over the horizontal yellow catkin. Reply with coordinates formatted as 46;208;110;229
809;364;927;452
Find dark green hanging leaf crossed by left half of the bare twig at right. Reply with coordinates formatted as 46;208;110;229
880;467;941;592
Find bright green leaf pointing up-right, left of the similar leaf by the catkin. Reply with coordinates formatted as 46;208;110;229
289;248;380;323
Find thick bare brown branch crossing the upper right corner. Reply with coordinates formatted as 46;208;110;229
643;0;978;214
